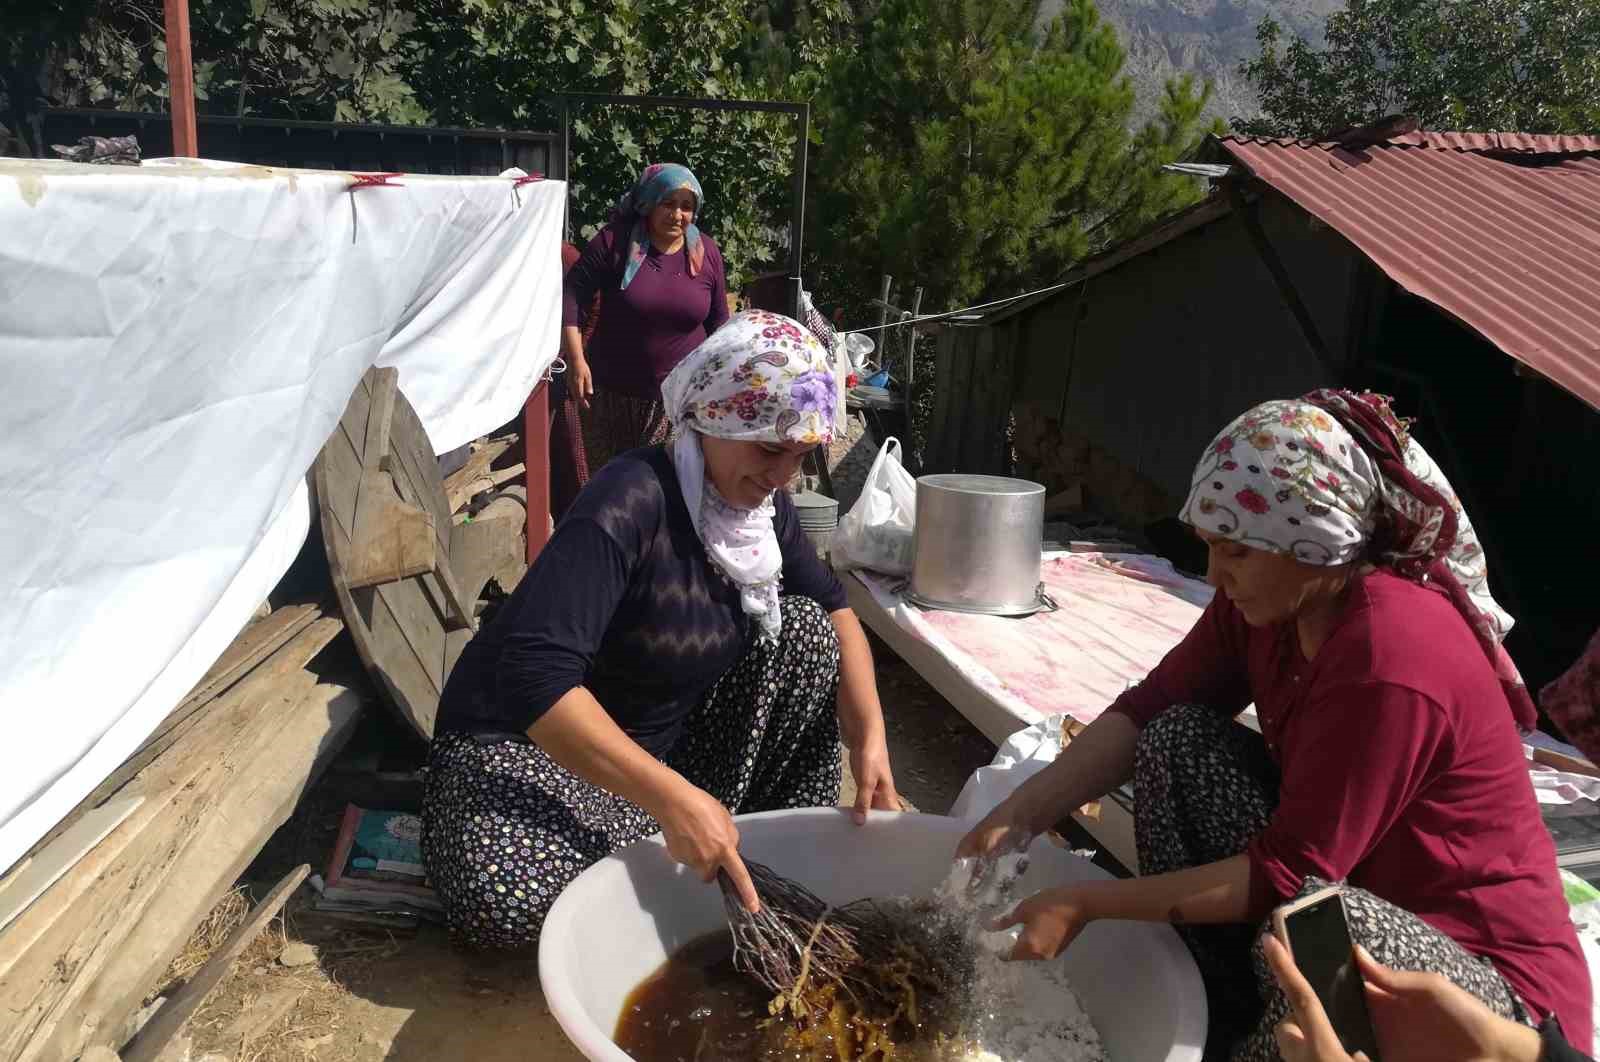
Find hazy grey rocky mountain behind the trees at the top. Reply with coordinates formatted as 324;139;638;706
1040;0;1344;122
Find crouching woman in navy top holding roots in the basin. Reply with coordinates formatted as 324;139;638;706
422;312;899;948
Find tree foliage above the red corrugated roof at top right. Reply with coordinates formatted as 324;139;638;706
1235;0;1600;136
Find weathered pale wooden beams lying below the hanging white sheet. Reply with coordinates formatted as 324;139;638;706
0;605;362;1062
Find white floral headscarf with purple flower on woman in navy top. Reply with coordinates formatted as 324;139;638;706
661;310;837;638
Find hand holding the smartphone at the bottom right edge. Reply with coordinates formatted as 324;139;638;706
1262;936;1541;1062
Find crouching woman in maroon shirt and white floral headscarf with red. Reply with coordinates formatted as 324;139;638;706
958;392;1590;1060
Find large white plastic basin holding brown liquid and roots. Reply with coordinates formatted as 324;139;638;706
539;808;1206;1062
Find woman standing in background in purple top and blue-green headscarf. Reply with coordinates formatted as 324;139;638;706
562;163;728;469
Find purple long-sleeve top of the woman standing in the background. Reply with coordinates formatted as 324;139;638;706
562;224;728;398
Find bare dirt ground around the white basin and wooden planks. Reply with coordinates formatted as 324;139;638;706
152;630;994;1062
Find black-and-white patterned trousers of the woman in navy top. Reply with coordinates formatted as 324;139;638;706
422;597;840;950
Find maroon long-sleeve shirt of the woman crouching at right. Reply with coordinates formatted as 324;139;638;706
1112;573;1592;1051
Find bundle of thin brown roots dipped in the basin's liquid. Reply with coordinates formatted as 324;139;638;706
718;860;976;1062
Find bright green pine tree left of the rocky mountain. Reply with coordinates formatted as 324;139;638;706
808;0;1205;309
